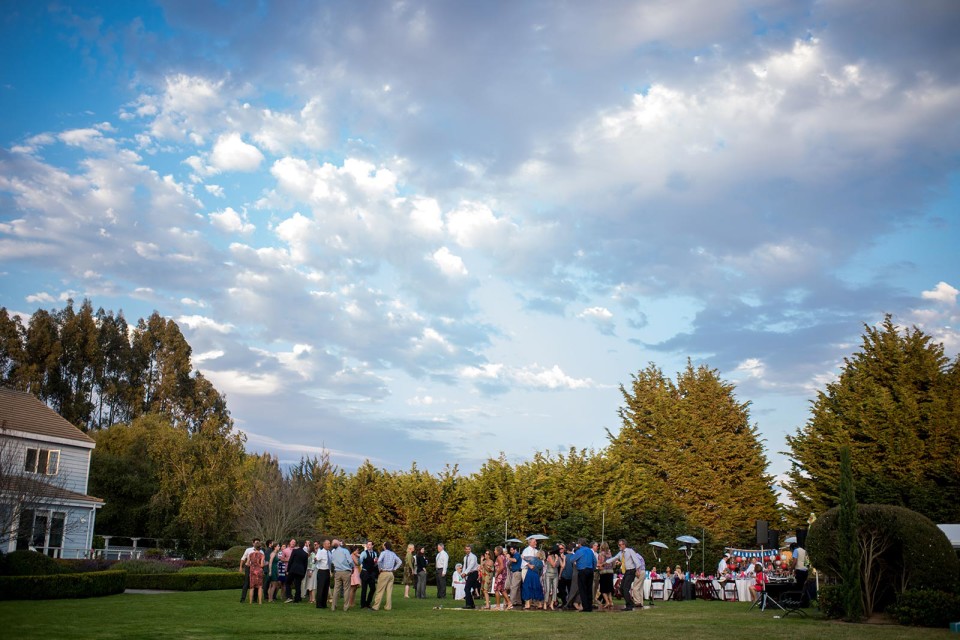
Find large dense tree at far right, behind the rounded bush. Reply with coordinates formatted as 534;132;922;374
787;315;960;522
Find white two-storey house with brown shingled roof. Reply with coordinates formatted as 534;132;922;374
0;387;103;558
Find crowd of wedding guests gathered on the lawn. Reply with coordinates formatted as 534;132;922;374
240;537;807;612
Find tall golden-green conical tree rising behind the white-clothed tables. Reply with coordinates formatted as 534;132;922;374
607;362;779;544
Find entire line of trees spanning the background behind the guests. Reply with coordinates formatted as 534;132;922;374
0;301;960;562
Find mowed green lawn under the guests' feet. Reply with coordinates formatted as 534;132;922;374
0;586;950;640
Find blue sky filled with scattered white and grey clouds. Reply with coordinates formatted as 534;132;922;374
0;0;960;488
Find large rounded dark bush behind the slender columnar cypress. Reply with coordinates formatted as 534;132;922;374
807;504;960;614
